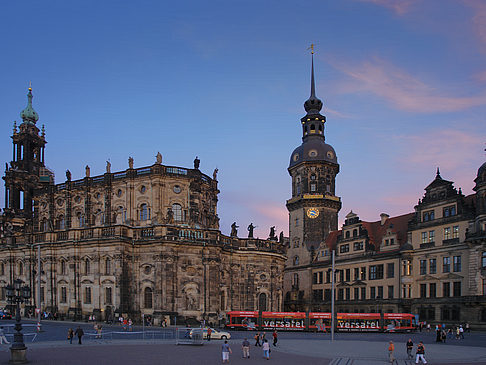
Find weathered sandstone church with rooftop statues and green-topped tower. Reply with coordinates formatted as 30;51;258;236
0;88;286;323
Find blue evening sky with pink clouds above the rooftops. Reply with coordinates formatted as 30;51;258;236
0;0;486;238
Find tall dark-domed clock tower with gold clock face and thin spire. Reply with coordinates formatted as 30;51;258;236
284;52;341;310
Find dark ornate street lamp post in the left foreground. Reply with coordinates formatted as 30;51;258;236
6;279;30;364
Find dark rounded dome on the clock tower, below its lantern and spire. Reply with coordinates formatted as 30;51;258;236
289;136;337;168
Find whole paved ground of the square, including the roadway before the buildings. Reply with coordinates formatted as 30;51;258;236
0;320;486;365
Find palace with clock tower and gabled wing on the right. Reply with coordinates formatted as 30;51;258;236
284;52;486;328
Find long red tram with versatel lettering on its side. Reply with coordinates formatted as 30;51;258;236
226;311;416;332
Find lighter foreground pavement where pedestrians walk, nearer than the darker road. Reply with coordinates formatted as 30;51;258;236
0;339;486;365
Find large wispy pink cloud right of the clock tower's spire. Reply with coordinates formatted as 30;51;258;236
334;57;486;113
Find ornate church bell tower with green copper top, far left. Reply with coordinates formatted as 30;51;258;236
3;87;52;232
